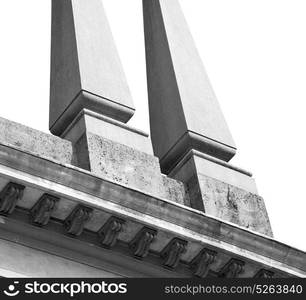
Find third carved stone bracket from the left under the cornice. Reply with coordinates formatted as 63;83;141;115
65;205;93;236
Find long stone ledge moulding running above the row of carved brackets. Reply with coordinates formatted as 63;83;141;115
0;146;306;277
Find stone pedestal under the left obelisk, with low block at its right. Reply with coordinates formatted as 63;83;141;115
62;109;187;204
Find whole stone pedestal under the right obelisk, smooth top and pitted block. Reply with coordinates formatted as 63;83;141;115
170;151;273;236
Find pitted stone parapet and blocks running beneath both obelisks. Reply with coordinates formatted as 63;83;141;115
0;118;272;236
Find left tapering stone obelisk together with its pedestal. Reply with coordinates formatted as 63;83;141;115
50;0;183;201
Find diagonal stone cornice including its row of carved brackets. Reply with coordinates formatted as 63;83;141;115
0;145;306;277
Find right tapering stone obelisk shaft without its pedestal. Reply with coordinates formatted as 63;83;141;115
143;0;236;174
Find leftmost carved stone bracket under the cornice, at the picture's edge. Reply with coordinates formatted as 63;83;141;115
0;182;25;215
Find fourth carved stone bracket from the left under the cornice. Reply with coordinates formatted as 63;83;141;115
98;217;125;249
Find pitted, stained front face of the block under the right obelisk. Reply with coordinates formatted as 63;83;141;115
198;175;273;236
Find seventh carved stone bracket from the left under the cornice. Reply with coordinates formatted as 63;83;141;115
190;249;217;278
